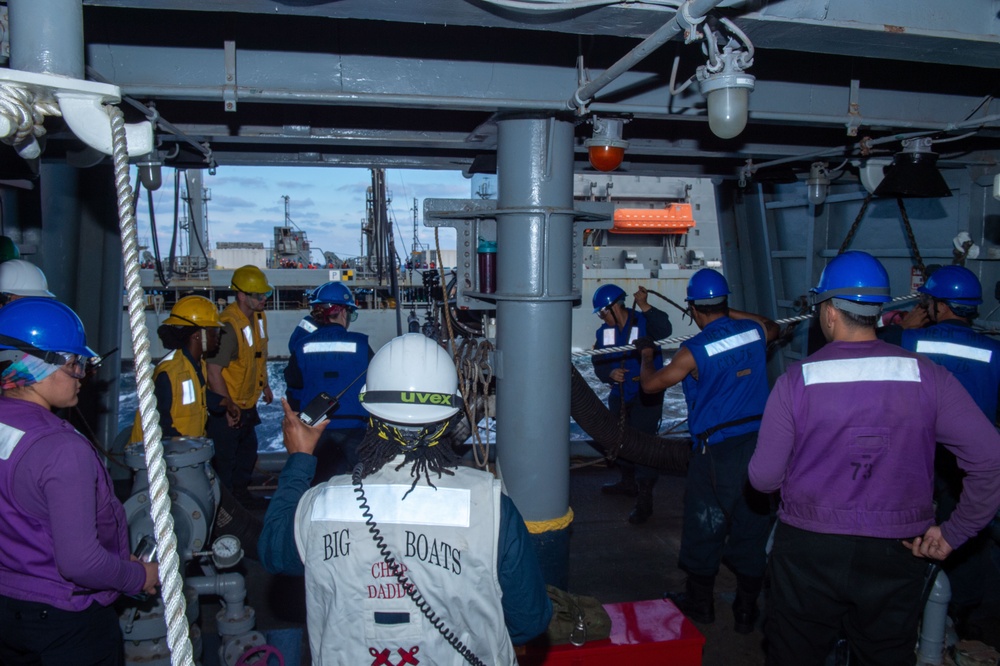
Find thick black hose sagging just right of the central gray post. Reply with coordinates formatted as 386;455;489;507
570;365;691;473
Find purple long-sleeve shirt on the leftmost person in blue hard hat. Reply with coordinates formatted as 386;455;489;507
0;398;146;610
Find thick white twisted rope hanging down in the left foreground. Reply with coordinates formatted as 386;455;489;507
106;105;194;666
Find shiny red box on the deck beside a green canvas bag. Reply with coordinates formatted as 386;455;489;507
518;599;705;666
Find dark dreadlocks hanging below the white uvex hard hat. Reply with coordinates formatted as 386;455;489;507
358;418;459;498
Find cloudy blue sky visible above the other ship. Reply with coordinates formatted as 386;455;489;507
133;166;472;260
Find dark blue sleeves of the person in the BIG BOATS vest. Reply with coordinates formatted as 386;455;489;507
257;453;552;645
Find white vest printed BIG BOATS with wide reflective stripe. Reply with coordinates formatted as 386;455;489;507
295;457;516;666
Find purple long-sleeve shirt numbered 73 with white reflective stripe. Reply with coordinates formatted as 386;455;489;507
749;341;1000;548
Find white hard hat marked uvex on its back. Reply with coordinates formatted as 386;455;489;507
360;333;461;425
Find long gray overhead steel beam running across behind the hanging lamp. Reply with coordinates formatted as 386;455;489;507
88;42;989;129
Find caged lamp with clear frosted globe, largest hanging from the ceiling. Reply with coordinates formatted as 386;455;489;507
695;29;755;139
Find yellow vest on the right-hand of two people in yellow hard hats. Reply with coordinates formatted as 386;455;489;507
219;303;267;409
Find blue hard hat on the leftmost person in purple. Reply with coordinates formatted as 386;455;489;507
0;297;98;362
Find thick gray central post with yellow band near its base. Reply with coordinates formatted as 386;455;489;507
496;116;573;586
